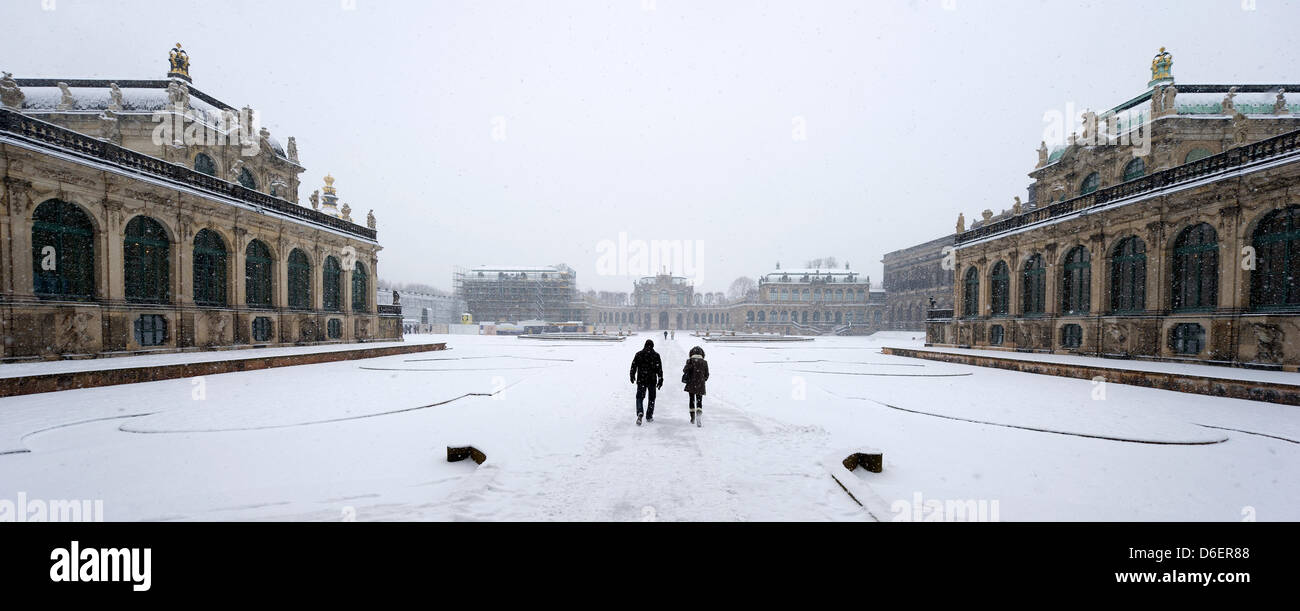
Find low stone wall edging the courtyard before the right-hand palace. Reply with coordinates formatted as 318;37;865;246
880;347;1300;406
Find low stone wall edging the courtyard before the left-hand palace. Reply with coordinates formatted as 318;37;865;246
0;343;447;397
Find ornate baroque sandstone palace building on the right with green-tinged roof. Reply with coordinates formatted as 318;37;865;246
927;49;1300;371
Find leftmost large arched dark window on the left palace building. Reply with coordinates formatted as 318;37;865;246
31;199;95;299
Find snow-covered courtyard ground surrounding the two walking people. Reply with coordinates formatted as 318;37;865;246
0;333;1300;521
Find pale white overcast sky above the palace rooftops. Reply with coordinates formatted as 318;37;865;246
0;0;1300;290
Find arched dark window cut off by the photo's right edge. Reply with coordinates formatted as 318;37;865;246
1251;205;1300;308
